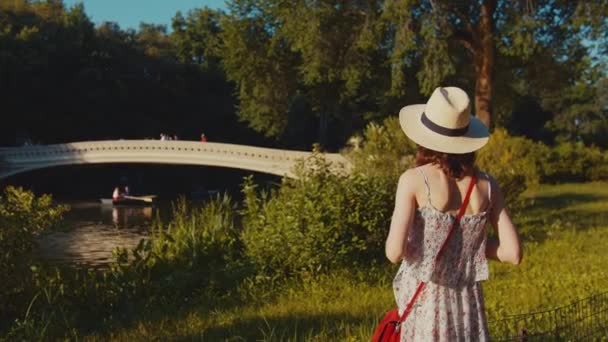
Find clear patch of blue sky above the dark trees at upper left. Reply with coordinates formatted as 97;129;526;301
63;0;226;30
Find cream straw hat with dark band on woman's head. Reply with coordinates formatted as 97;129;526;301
399;87;489;154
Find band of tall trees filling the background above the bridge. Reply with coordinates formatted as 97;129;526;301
0;0;608;149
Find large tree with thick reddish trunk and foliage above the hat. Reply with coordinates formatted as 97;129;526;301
385;0;608;126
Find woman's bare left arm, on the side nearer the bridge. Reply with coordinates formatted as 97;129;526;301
385;169;416;263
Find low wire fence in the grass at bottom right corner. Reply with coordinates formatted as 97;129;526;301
488;292;608;341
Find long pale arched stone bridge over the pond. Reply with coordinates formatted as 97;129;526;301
0;140;350;179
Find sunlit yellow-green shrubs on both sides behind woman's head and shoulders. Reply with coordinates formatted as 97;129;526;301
344;117;608;206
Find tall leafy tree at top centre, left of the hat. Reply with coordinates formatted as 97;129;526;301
275;0;388;145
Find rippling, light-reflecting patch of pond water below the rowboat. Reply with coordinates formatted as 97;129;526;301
35;202;158;266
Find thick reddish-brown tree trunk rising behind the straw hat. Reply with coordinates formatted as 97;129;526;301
475;0;496;127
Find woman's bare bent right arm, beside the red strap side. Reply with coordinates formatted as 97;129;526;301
486;178;522;265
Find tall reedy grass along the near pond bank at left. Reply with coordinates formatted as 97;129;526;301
0;192;242;340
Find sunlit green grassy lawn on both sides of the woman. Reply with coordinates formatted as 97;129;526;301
85;182;608;341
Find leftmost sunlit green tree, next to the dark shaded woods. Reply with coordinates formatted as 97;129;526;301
220;0;297;138
